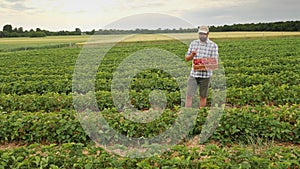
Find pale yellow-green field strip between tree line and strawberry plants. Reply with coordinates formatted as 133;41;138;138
0;32;300;51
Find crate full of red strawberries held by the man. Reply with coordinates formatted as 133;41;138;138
193;58;218;70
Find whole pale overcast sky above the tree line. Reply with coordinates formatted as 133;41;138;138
0;0;300;31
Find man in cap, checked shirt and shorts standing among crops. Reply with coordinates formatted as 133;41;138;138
185;26;219;108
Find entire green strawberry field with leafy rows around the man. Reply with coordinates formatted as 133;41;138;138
0;36;300;169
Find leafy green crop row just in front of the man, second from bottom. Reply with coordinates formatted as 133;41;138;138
0;105;300;144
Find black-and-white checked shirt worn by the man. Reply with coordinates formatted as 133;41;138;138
186;39;219;78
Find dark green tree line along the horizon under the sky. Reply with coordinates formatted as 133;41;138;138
0;21;300;38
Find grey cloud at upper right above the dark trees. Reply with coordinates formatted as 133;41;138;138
182;0;300;25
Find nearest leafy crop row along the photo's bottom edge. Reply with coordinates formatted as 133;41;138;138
0;143;300;169
